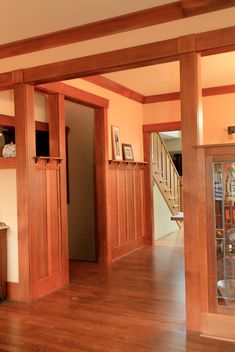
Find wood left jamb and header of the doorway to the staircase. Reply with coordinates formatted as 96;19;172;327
143;121;181;245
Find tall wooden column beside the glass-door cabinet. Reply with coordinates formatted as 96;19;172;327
180;52;202;331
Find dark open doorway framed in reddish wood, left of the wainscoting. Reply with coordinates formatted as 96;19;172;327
65;100;98;262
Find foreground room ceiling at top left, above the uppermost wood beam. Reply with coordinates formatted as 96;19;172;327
0;0;174;44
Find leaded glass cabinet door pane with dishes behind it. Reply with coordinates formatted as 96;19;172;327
213;161;235;308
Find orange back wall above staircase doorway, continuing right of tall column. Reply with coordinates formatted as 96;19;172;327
144;94;235;144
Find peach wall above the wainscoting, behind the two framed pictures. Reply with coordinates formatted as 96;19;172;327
65;79;143;161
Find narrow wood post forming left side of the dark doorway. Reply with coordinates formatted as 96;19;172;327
48;94;69;285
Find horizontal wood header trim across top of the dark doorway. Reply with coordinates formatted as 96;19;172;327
36;82;109;108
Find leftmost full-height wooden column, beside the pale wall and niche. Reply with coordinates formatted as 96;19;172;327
14;84;35;302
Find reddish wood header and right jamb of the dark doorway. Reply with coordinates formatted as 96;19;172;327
42;83;111;263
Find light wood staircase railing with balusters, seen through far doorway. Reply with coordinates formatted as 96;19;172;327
151;132;183;221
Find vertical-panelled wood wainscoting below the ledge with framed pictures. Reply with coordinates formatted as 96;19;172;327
108;161;146;260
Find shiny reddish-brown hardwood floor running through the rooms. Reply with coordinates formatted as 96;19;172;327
0;247;235;352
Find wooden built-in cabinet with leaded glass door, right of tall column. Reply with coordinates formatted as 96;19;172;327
196;144;235;340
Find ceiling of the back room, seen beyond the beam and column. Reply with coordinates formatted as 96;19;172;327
104;51;235;96
